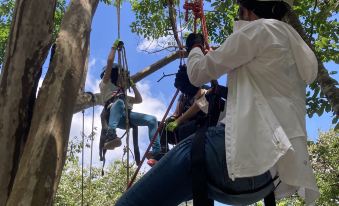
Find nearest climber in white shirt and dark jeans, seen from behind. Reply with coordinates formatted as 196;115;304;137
116;0;319;206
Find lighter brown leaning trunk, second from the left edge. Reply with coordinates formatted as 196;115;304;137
7;0;98;206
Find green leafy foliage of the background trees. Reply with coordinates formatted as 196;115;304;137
0;0;339;205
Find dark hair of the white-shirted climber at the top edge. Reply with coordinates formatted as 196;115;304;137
238;0;289;20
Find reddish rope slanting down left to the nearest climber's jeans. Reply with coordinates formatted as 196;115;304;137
127;89;179;189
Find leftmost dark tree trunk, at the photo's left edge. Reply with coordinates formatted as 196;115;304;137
0;0;56;205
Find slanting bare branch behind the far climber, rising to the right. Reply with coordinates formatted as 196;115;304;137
73;49;180;113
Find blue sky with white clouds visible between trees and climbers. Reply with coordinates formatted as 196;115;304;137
61;2;339;205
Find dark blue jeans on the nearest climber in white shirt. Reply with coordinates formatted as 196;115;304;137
116;125;274;206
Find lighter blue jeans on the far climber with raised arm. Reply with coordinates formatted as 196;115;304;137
108;99;160;153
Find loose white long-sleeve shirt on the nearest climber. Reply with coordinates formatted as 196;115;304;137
187;19;319;204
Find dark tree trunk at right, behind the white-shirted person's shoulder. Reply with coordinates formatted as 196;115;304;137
286;10;339;115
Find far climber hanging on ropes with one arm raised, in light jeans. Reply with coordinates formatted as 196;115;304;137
99;40;160;162
